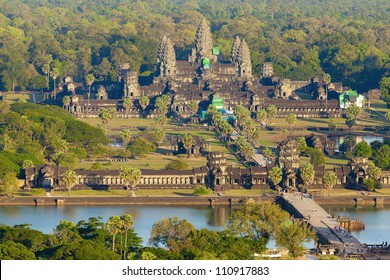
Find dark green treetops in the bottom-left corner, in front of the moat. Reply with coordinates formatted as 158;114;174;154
0;218;141;260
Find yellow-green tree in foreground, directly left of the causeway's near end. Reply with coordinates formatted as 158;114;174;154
275;220;315;259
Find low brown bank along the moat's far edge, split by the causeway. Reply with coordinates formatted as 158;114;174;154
0;194;390;206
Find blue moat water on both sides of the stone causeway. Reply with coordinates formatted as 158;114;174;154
0;205;390;247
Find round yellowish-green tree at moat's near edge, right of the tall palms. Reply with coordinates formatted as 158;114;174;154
149;217;195;253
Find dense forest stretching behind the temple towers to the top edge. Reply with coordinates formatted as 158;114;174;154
0;0;390;91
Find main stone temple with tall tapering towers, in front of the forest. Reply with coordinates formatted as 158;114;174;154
54;20;343;118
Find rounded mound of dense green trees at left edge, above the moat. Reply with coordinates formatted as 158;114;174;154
0;101;107;177
